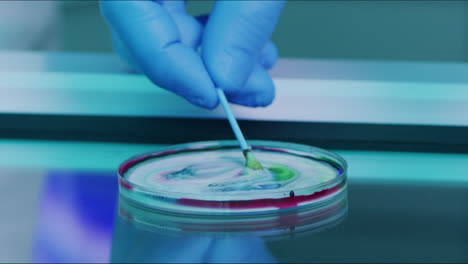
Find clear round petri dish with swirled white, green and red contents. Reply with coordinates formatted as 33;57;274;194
118;140;347;216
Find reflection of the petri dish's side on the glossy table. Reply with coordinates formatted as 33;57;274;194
118;189;348;241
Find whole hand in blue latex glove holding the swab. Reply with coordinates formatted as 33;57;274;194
101;0;284;108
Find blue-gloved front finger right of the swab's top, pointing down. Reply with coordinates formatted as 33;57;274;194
202;1;285;93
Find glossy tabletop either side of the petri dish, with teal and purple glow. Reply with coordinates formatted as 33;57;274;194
0;140;468;263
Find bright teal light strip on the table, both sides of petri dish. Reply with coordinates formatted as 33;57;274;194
0;140;468;185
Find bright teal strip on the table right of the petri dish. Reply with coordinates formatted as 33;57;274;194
337;151;468;185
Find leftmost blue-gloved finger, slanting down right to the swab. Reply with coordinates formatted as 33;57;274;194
101;0;218;108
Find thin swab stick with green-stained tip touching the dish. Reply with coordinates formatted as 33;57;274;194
216;88;263;170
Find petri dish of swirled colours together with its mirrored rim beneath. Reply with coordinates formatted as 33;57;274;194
118;140;347;238
